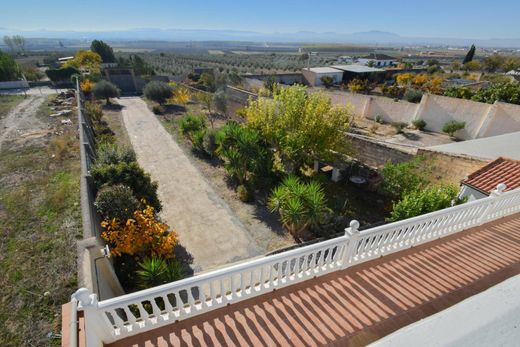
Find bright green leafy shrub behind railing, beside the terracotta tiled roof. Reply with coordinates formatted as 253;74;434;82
389;185;465;221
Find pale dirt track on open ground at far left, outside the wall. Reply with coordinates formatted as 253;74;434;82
0;96;47;150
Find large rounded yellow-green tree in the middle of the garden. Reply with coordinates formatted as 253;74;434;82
244;85;351;170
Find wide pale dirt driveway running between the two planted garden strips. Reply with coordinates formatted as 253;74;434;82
119;97;264;272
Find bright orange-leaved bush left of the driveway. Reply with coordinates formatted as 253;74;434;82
101;206;178;258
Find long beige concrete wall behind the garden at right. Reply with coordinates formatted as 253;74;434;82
326;91;520;140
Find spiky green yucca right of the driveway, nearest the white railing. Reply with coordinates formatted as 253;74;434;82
268;175;328;239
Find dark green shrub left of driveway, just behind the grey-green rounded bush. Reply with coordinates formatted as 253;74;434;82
90;162;161;212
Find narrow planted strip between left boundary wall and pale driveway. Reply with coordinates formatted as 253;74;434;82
81;79;190;292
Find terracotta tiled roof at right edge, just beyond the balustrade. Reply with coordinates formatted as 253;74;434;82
462;157;520;194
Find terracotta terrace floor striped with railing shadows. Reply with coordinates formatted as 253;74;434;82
109;214;520;347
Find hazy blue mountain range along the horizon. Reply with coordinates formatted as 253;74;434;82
0;28;520;48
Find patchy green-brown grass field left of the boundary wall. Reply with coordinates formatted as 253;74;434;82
0;96;81;346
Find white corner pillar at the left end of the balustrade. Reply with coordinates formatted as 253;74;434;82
72;288;113;347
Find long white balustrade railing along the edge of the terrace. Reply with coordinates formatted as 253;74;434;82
69;184;520;346
